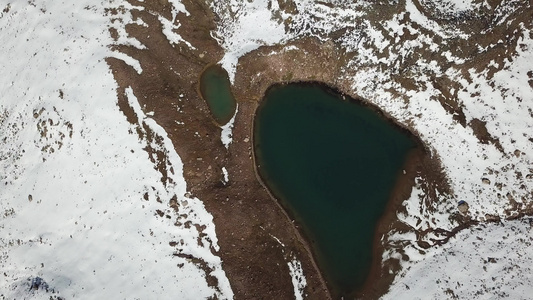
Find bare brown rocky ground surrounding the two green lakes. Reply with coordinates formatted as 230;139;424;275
108;0;448;299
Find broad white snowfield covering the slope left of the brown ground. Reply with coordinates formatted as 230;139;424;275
0;1;233;299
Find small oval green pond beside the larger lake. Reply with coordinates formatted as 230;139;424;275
200;65;237;125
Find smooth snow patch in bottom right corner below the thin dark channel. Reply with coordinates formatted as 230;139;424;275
382;219;533;300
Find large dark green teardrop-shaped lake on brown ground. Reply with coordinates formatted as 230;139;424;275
254;84;416;297
